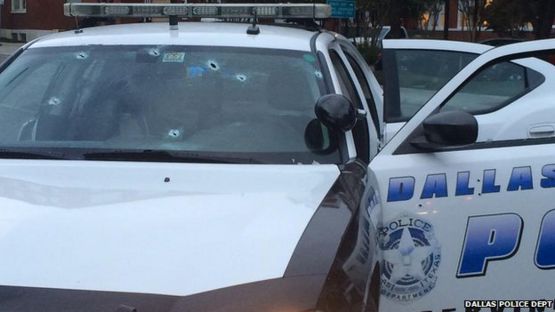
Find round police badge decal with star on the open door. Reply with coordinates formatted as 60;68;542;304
378;214;441;303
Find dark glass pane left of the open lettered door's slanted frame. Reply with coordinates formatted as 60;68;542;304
384;50;477;122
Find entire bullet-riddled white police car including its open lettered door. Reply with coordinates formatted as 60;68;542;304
0;3;555;312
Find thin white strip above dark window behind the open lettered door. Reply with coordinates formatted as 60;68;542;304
383;39;493;54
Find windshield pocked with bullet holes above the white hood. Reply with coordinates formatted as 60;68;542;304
0;46;339;164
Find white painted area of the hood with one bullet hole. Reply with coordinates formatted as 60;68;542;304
0;160;339;296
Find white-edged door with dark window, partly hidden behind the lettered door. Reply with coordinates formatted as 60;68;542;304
374;39;491;142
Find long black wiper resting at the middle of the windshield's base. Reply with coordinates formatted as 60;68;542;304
83;149;262;164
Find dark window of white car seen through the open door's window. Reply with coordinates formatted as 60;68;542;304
443;62;543;114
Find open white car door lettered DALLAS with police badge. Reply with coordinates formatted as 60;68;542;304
369;40;555;312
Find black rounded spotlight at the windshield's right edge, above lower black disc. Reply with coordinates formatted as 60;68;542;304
314;94;357;132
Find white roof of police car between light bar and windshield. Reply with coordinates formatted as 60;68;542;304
29;22;316;51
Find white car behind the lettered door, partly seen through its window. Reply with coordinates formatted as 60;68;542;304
380;40;555;142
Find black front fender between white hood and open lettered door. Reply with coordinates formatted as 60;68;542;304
284;161;373;311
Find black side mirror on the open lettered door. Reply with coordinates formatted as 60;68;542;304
411;111;478;150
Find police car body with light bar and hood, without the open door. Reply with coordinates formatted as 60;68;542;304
0;3;379;312
